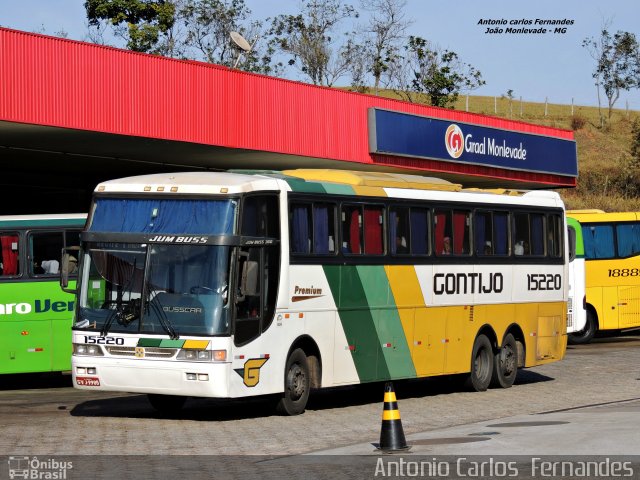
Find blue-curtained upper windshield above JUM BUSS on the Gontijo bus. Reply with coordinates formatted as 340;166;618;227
89;198;235;235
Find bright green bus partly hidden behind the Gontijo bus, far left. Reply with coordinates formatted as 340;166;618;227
0;214;87;374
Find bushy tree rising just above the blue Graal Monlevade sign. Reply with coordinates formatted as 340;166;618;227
394;36;486;107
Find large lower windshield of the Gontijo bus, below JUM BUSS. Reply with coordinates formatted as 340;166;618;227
74;242;231;338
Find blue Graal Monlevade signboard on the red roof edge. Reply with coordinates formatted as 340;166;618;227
369;108;578;177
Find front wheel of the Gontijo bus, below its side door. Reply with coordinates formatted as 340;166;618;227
276;348;311;415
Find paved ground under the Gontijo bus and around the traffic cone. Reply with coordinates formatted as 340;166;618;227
0;330;640;457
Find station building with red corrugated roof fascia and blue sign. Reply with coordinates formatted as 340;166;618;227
0;28;578;214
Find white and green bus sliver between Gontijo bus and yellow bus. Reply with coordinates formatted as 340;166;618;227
567;217;587;343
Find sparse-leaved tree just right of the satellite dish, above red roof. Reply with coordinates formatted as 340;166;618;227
269;0;357;86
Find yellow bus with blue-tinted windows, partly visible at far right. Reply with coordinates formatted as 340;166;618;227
567;210;640;344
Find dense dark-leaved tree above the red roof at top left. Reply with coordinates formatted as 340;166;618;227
84;0;175;52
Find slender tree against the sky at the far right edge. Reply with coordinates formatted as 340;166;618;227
582;22;640;123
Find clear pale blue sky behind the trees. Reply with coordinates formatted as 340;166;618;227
0;0;640;110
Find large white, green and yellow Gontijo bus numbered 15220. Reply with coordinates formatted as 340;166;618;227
67;170;568;414
